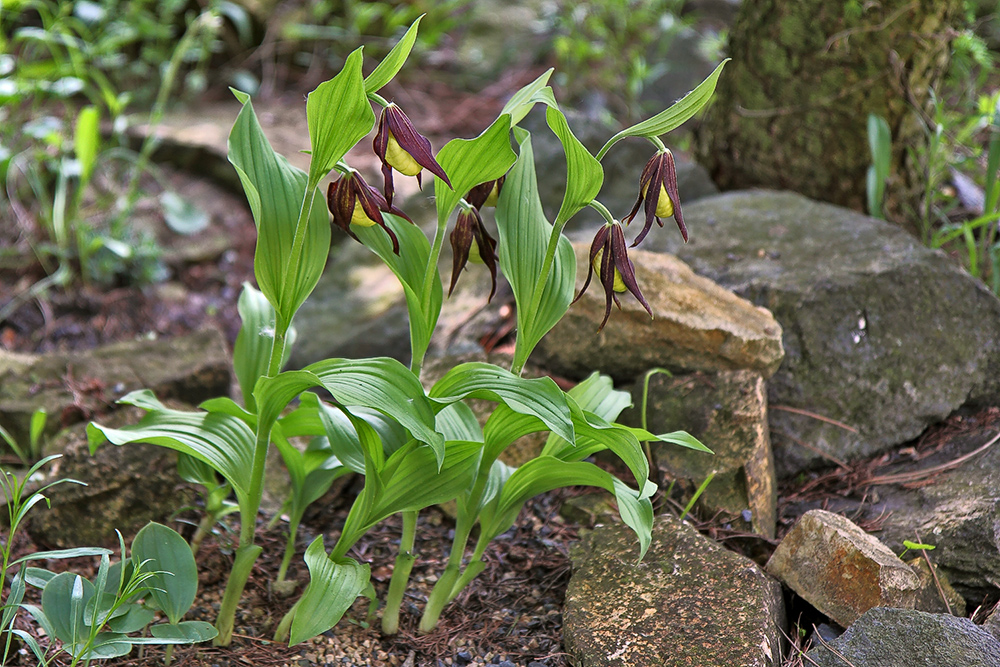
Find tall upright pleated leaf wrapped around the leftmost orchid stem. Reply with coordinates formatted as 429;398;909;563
229;96;330;323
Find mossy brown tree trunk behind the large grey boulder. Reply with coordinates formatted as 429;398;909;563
696;0;965;227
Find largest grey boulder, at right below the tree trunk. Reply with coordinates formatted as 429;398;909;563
642;191;1000;476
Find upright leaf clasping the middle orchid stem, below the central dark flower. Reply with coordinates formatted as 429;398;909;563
354;213;444;368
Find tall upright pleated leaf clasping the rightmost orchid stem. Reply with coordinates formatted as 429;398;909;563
496;128;576;374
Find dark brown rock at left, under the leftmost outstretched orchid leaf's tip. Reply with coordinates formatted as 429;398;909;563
27;408;196;549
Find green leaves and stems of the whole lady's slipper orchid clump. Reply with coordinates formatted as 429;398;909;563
89;19;722;645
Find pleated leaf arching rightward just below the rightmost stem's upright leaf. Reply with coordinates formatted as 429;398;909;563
429;362;574;442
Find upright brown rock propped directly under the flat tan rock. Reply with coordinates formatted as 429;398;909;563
623;371;777;537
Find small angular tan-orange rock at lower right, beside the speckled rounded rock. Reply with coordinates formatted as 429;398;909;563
767;510;920;628
